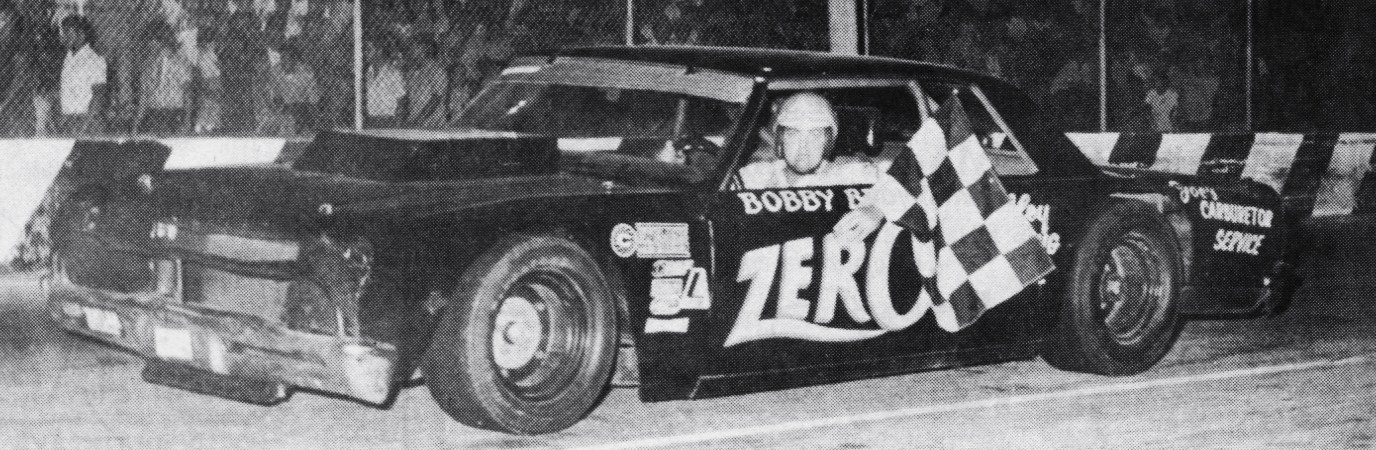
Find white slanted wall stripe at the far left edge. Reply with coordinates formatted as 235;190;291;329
0;139;74;264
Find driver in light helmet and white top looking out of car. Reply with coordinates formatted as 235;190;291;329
739;92;878;190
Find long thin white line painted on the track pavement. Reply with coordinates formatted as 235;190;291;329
575;355;1373;450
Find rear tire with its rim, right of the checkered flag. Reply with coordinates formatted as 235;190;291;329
1042;201;1183;376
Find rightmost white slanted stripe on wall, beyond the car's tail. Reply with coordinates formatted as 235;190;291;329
1314;133;1376;217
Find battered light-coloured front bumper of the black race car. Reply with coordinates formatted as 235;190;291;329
48;271;398;405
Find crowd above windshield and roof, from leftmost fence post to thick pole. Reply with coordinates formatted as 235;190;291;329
365;0;828;127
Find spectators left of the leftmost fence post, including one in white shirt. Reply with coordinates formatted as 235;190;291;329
0;0;354;136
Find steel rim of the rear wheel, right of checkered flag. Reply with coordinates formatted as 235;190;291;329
1097;231;1171;345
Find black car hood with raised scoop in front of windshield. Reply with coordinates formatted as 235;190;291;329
131;131;696;239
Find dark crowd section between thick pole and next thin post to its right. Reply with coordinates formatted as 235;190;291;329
870;0;1099;129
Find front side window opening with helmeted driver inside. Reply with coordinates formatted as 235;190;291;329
733;83;922;190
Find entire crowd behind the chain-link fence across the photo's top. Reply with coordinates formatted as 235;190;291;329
0;0;1376;136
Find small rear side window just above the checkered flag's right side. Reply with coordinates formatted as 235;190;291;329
922;83;1038;176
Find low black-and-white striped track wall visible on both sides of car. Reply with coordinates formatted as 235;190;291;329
0;133;1376;270
